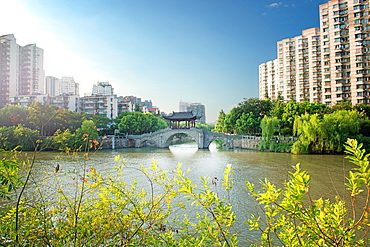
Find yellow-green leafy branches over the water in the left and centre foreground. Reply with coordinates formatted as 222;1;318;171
0;157;237;246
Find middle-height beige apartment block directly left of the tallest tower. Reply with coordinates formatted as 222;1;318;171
275;28;321;102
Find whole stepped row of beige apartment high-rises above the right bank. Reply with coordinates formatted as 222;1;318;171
259;0;370;105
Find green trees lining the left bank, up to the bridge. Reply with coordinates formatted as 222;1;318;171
0;102;168;150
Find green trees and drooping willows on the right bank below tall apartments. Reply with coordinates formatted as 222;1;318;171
213;98;370;153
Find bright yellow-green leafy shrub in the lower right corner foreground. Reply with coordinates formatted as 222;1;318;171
246;140;370;246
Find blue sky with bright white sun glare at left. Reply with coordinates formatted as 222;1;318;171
0;0;327;123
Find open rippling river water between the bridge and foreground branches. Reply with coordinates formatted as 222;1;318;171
10;144;360;246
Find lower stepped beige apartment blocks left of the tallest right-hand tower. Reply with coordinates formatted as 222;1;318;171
259;28;321;102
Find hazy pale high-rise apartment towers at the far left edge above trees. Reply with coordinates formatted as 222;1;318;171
0;34;44;108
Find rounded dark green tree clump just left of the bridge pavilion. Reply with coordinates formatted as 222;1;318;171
118;112;168;135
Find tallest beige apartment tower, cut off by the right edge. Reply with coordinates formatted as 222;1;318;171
320;0;370;105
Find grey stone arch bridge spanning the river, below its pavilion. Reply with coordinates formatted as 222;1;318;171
127;128;242;149
